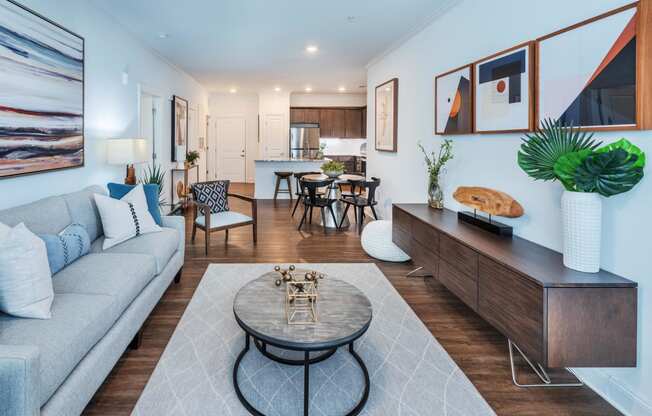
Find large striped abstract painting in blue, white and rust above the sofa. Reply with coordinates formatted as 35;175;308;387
0;0;84;178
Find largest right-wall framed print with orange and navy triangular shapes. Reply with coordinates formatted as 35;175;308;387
537;4;638;130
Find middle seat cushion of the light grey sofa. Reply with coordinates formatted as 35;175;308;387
52;254;156;313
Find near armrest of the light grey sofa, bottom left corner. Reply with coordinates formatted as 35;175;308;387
0;345;41;416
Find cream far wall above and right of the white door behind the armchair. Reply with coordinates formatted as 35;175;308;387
208;93;259;182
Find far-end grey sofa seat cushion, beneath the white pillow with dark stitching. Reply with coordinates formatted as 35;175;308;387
91;228;179;274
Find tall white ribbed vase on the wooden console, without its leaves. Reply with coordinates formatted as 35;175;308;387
561;191;602;273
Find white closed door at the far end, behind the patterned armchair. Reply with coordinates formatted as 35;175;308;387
215;117;247;182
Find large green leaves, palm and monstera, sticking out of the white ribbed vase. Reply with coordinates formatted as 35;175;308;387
518;120;645;197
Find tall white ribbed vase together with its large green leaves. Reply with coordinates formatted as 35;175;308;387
518;120;645;273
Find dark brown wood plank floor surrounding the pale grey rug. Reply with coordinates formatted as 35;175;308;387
85;184;620;415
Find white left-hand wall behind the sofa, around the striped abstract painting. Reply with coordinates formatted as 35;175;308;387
0;0;207;209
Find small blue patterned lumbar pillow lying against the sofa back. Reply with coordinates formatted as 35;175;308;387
39;224;91;274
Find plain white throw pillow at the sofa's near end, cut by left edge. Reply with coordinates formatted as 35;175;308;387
0;223;54;319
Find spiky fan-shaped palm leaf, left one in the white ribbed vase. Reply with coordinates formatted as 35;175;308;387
518;119;600;181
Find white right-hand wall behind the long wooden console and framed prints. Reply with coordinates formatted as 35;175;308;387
367;0;652;415
